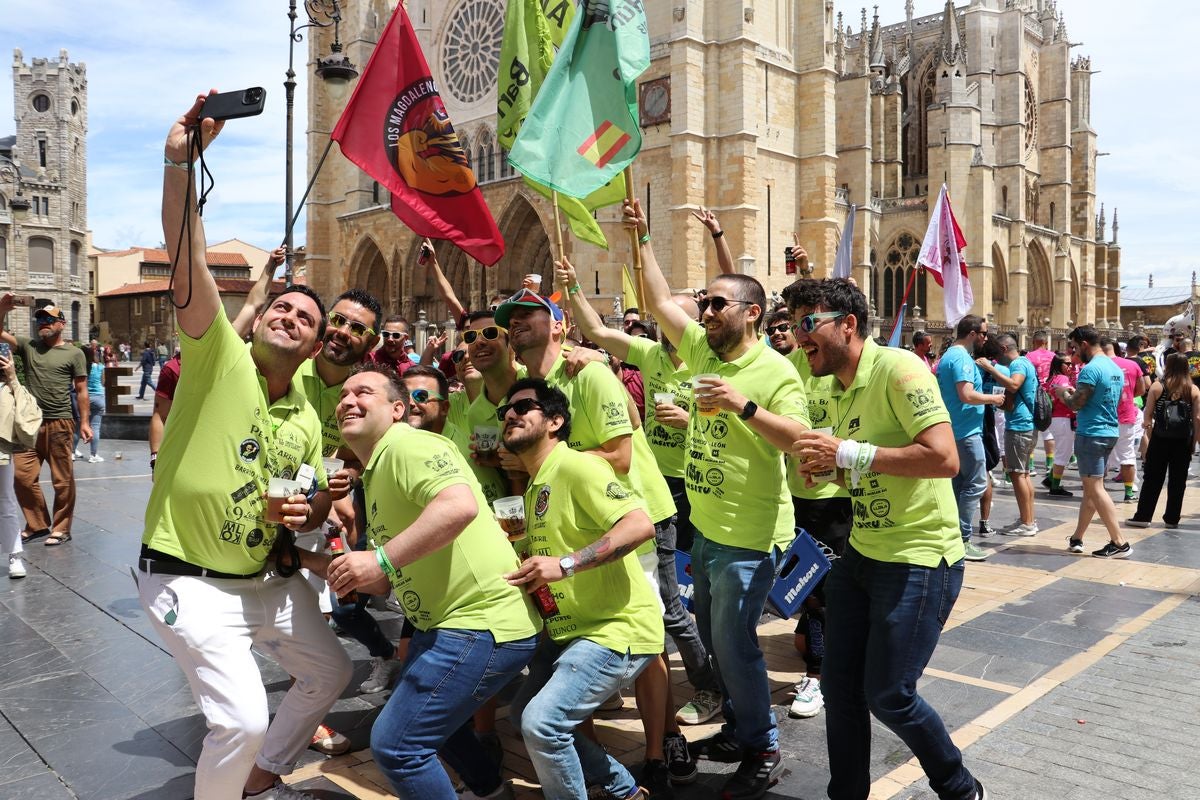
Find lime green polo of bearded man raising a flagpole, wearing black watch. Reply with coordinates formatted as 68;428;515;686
679;323;809;553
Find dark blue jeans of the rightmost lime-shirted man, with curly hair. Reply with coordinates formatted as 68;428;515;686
821;546;974;800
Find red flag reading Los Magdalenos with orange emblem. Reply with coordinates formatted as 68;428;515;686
332;4;504;265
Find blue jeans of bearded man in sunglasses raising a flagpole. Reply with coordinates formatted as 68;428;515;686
691;530;782;752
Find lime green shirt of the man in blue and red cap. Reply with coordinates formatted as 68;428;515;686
546;356;676;523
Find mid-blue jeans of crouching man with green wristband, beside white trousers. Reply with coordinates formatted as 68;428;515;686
371;628;538;800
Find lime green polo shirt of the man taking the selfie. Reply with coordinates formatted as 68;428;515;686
142;313;328;575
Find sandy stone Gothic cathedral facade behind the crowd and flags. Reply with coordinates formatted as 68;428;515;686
307;0;1120;335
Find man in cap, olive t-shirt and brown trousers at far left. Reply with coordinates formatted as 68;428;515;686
0;303;91;547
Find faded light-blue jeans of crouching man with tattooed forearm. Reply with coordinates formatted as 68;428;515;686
508;637;659;800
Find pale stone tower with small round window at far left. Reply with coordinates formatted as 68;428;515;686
0;50;92;341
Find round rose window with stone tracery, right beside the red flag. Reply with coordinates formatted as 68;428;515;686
442;0;504;106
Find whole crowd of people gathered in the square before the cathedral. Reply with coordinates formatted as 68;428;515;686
9;97;1200;800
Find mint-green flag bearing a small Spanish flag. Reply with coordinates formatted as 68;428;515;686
509;0;650;198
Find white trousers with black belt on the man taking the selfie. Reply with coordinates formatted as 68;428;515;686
138;572;352;800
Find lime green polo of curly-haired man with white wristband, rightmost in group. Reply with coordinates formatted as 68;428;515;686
833;339;962;567
